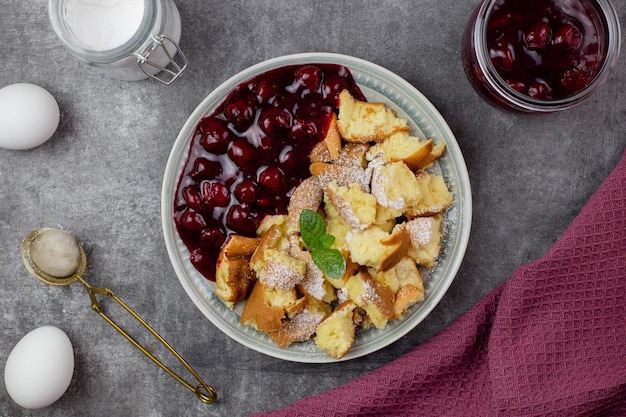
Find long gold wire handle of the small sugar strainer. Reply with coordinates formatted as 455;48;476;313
78;276;217;404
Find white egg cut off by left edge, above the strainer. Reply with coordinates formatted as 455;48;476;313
0;83;60;149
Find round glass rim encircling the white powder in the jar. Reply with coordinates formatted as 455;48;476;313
48;0;158;64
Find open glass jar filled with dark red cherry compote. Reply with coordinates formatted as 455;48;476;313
463;0;621;113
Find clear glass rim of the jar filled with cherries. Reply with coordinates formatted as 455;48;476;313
472;0;621;112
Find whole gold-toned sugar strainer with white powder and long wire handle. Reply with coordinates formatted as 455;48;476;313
22;228;217;404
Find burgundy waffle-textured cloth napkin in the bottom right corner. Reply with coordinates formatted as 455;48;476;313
257;149;626;417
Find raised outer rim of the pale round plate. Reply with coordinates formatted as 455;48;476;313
161;52;472;363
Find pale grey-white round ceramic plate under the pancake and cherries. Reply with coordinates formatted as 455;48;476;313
161;53;472;363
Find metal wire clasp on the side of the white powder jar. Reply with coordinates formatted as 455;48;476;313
133;35;188;85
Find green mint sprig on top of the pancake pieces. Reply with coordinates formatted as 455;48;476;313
300;209;346;279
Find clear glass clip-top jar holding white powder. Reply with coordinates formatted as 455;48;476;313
48;0;187;84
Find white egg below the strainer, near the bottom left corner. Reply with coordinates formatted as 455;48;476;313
4;326;74;409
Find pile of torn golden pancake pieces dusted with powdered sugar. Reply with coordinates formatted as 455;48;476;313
215;91;454;359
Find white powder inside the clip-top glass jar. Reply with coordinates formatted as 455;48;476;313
63;0;144;51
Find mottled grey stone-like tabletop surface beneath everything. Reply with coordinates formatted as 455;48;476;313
0;0;626;417
